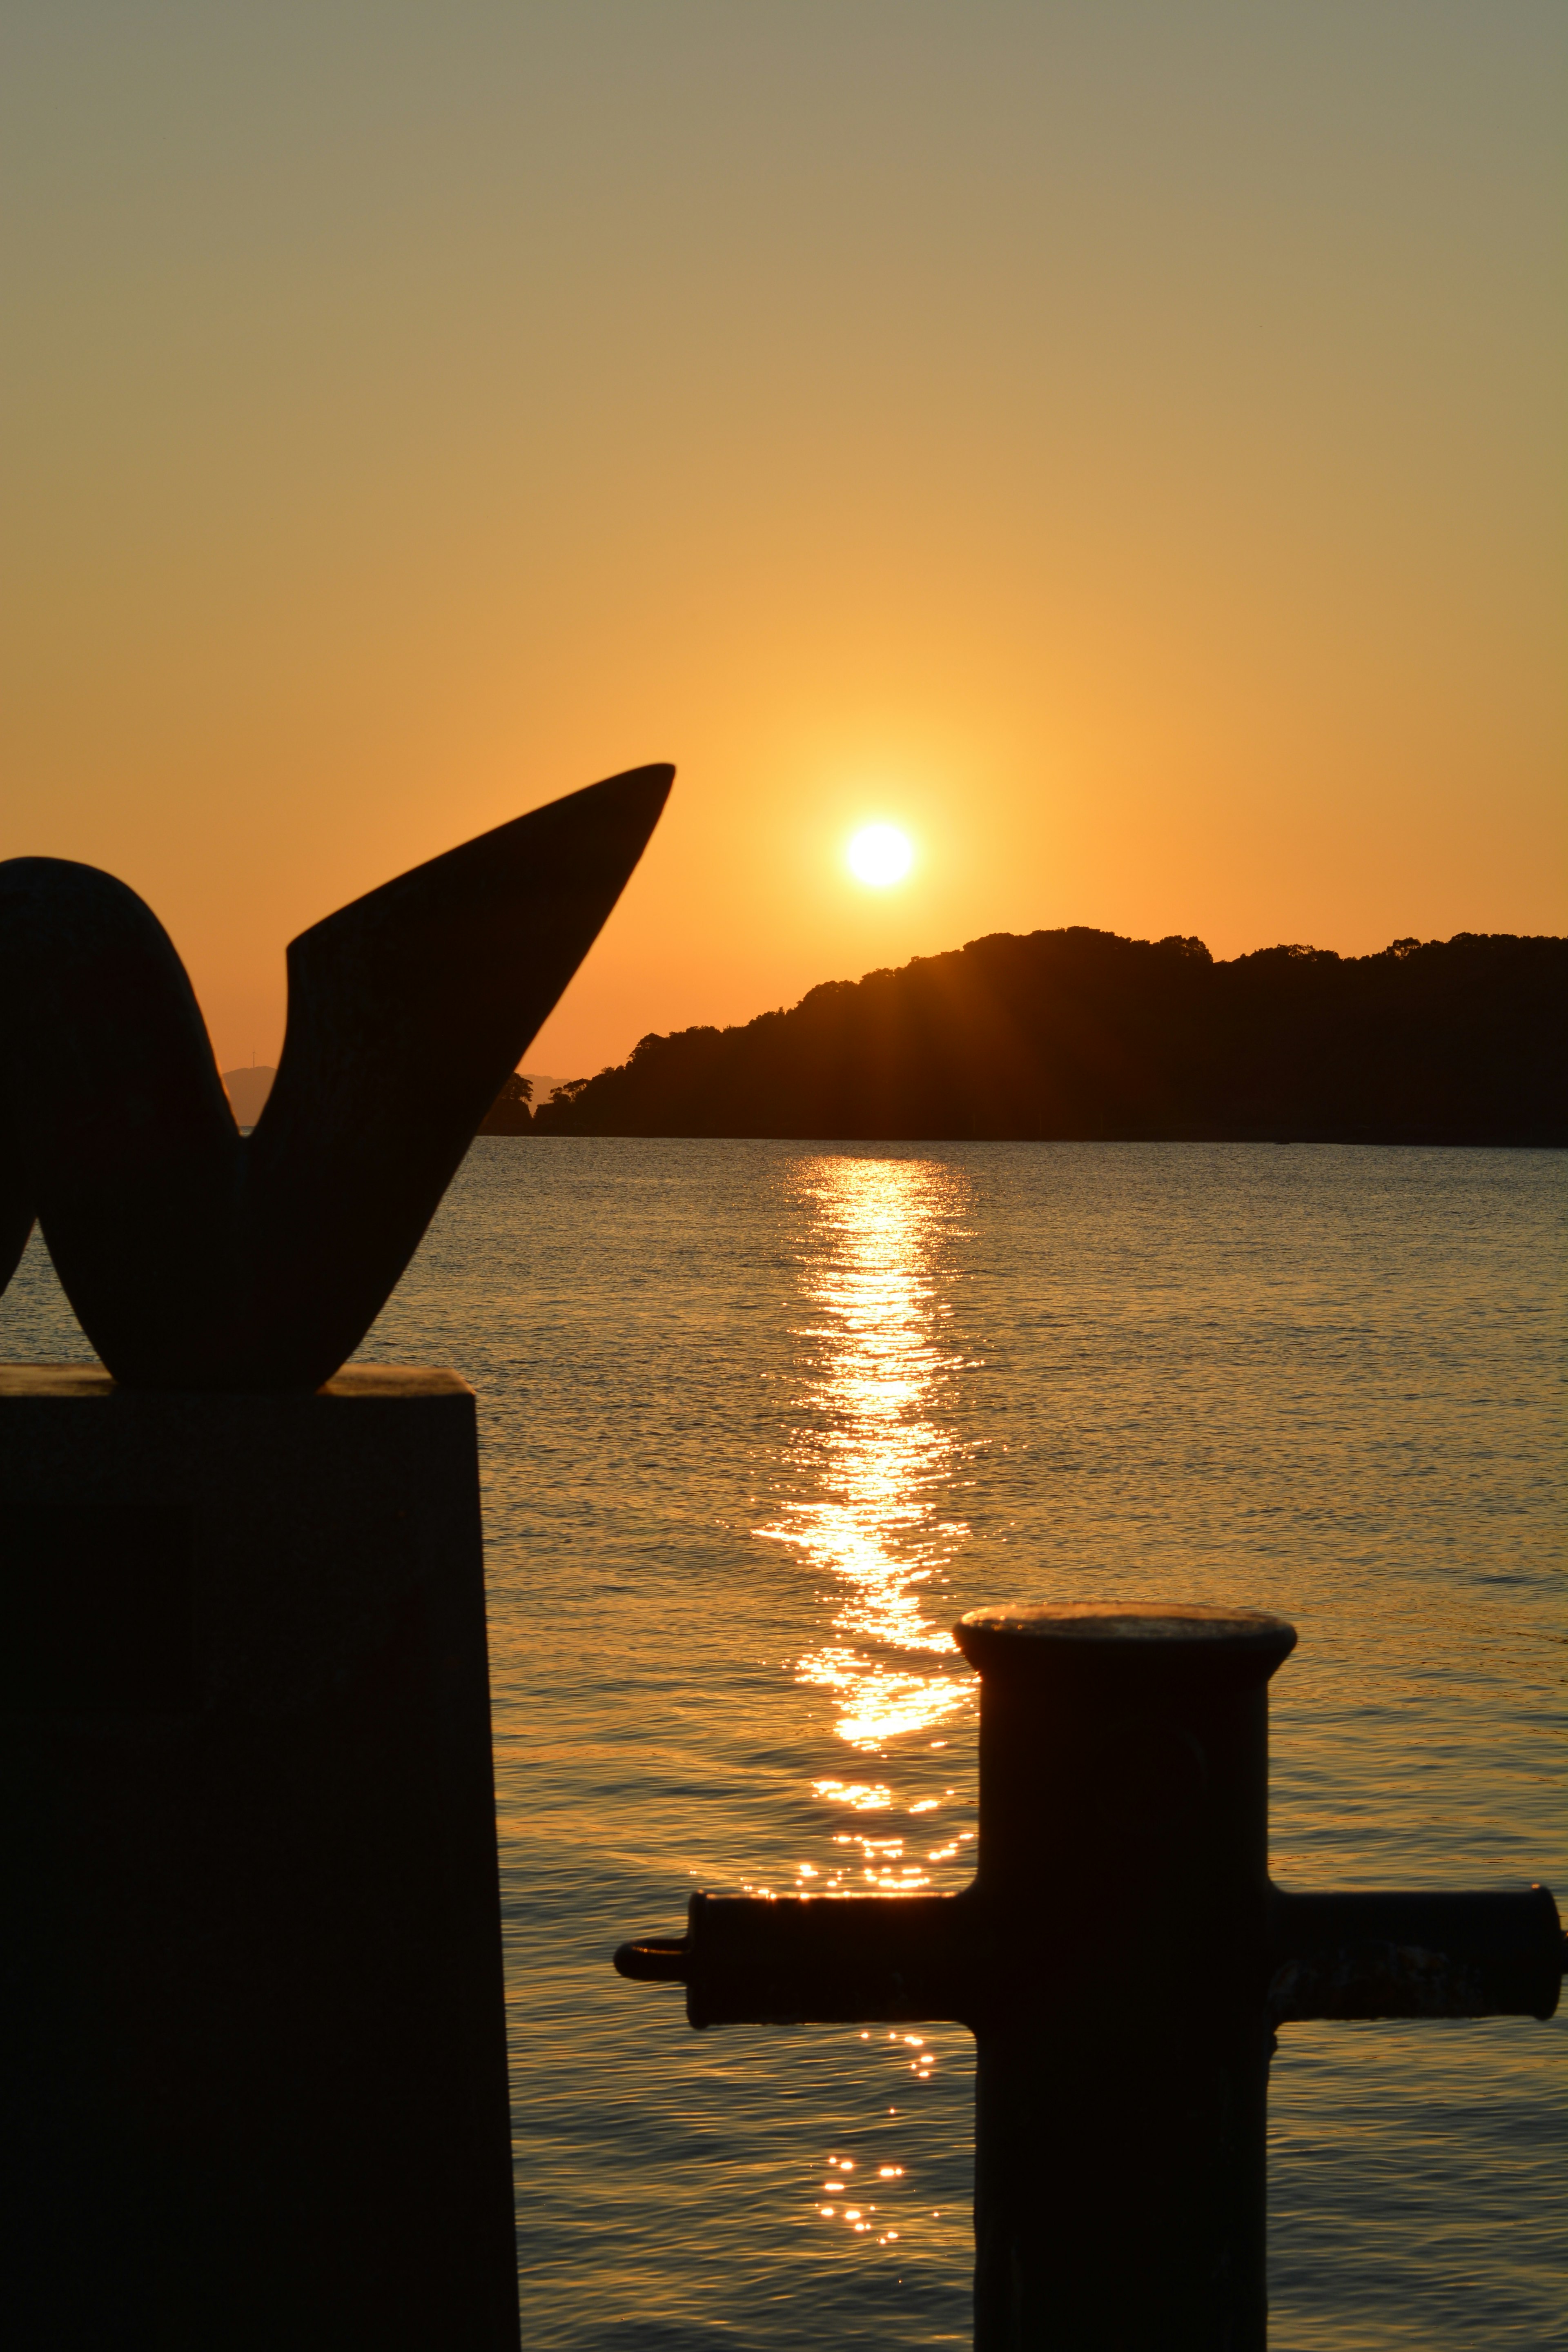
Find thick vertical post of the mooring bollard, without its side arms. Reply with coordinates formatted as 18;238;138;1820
962;1609;1295;2352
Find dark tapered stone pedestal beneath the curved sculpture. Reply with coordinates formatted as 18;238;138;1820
0;1367;517;2352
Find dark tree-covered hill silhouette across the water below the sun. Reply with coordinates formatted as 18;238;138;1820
510;927;1568;1145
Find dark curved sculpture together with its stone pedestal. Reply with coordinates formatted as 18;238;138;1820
0;767;670;2352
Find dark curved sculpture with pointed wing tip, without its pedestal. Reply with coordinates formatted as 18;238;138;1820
0;767;675;1390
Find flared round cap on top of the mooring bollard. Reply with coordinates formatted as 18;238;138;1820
952;1599;1295;1672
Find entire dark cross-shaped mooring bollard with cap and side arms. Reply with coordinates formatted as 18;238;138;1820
616;1604;1563;2352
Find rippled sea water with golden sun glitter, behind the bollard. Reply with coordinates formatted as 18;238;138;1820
0;1138;1568;2352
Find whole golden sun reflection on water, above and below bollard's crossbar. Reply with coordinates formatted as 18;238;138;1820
750;1157;976;2265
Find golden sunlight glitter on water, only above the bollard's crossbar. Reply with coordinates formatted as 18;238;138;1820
757;1160;971;1889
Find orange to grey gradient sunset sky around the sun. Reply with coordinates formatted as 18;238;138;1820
0;0;1568;1075
